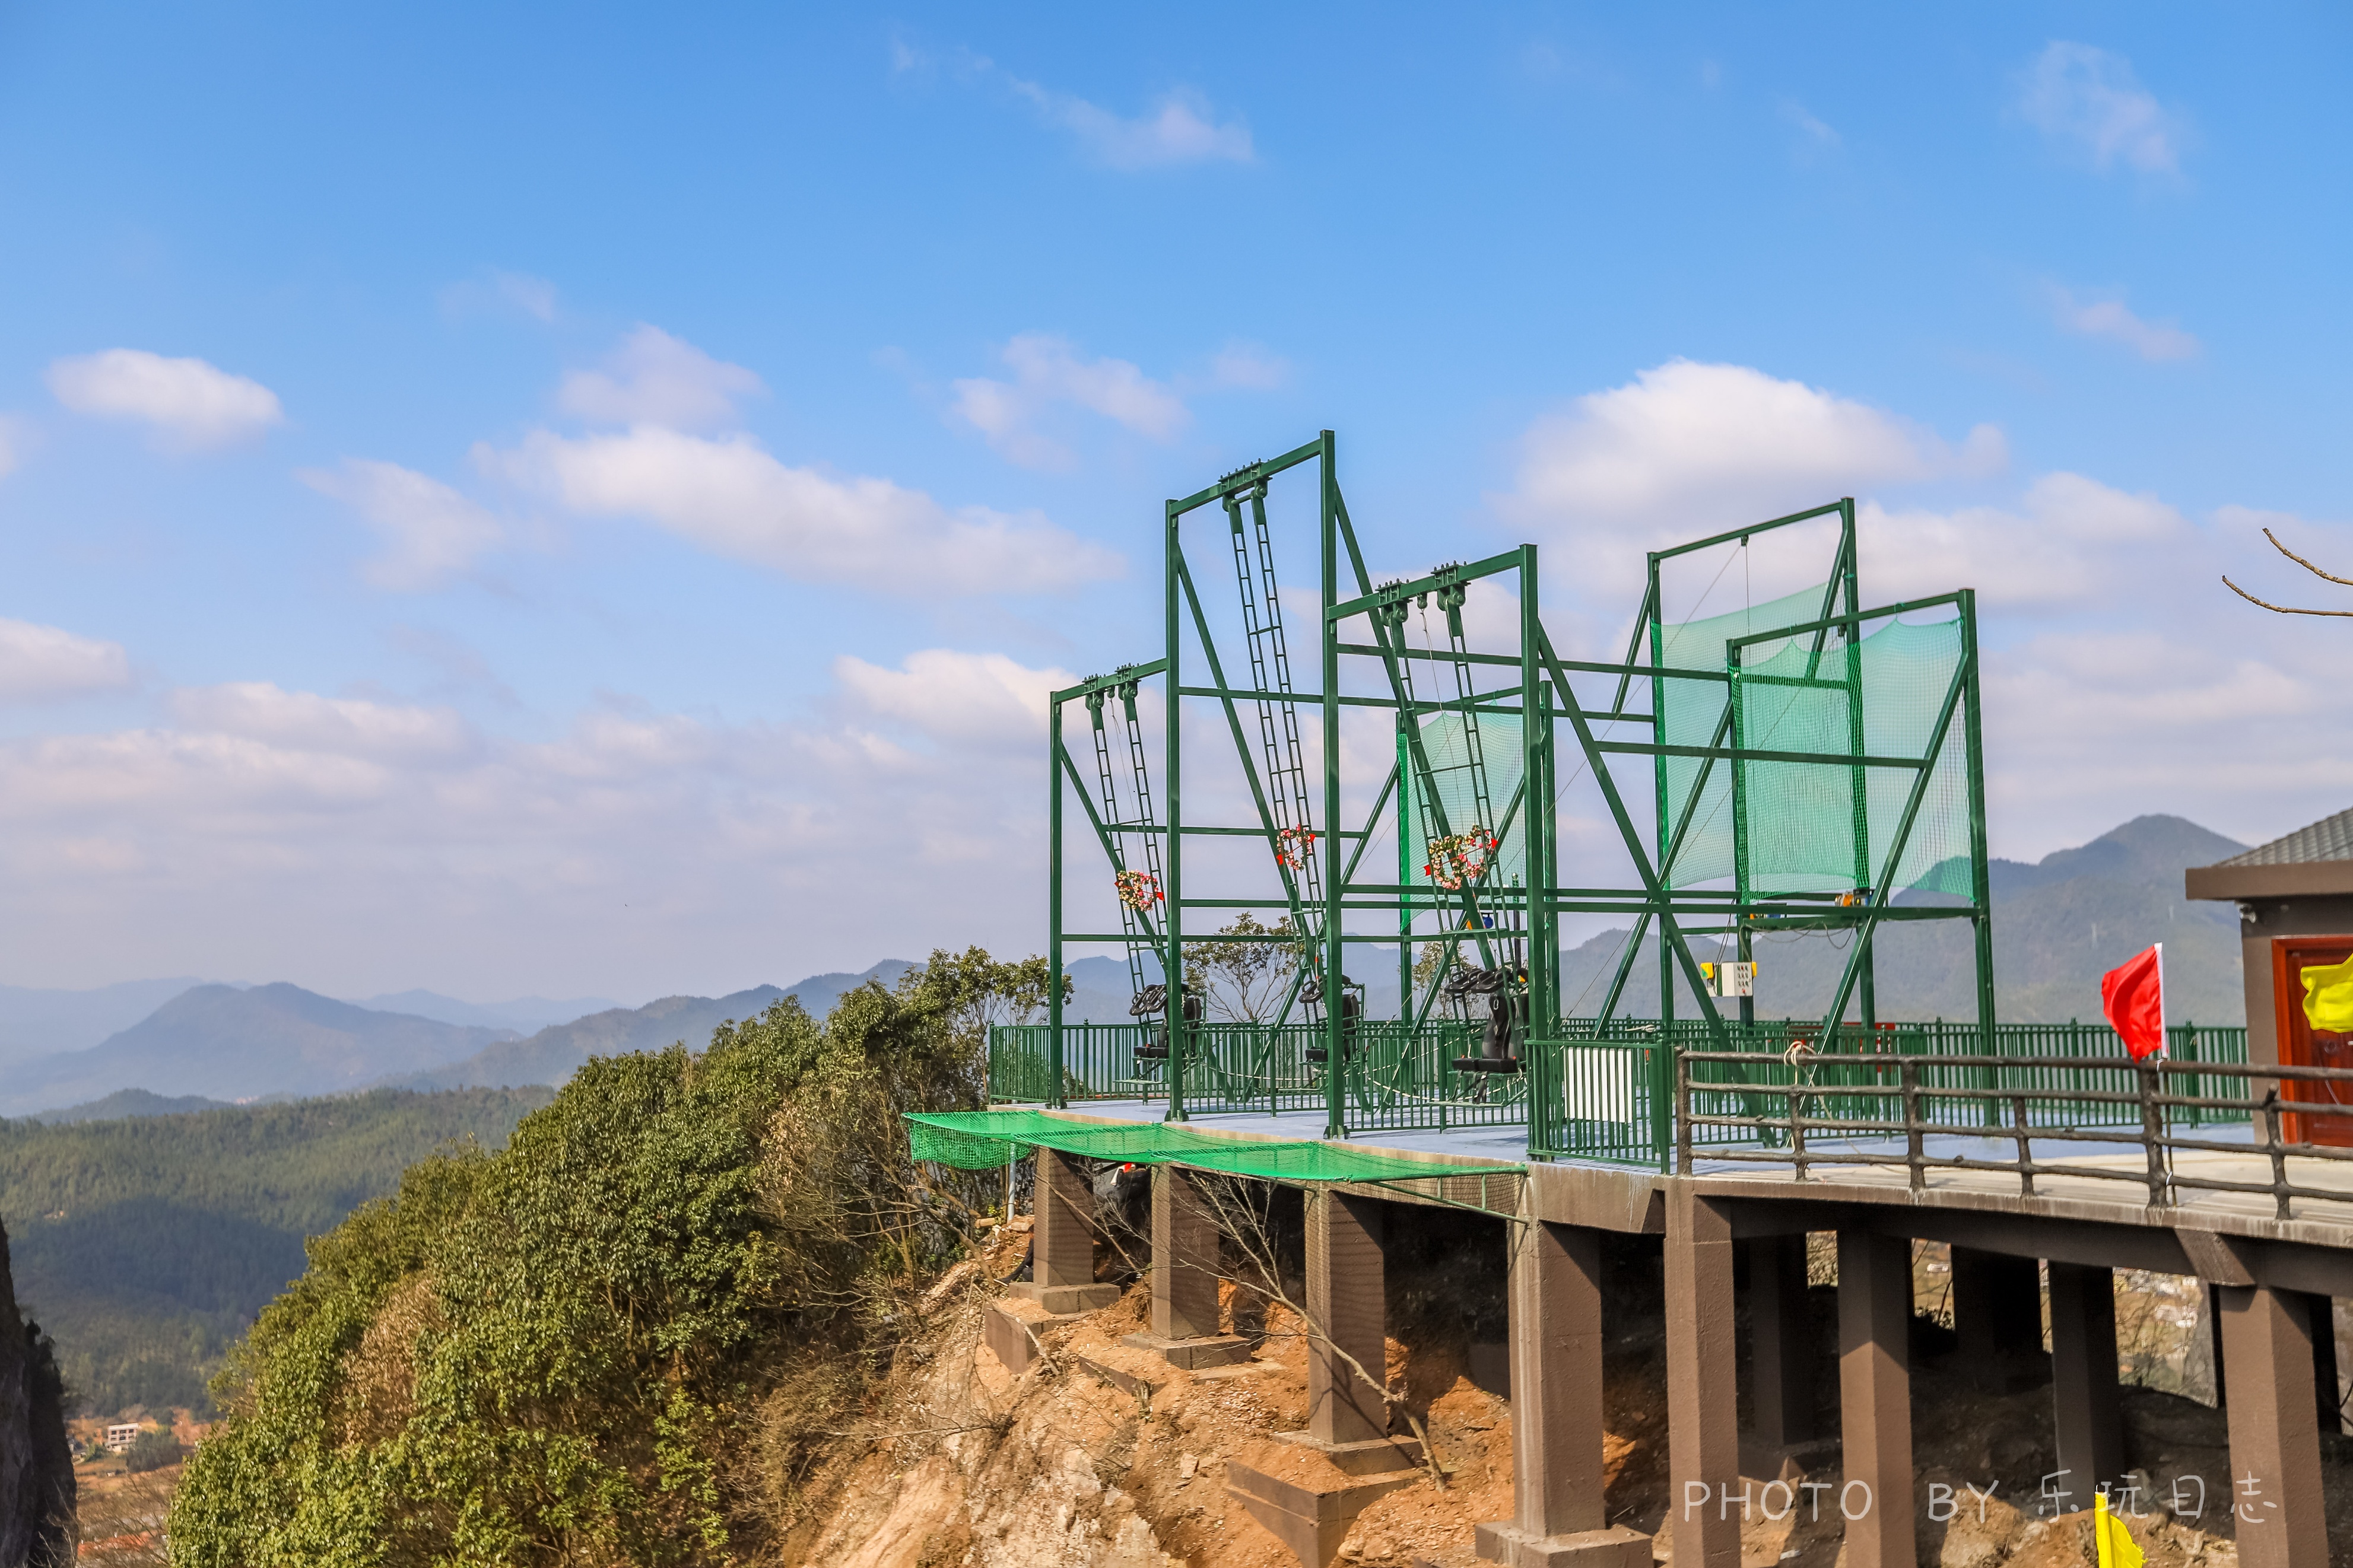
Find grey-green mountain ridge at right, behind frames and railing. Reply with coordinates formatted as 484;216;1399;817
1563;816;2247;1025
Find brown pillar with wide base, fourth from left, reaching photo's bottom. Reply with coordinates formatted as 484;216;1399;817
1475;1220;1649;1568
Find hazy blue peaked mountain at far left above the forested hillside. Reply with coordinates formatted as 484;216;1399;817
0;982;515;1117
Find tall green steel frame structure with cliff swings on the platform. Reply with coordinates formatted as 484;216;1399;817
1036;430;1995;1157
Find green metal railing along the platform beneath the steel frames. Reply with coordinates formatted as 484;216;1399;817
988;1018;2250;1168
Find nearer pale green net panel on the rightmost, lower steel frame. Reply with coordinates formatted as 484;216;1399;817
1734;621;1970;896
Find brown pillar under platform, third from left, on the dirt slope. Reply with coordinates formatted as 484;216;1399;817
1309;1187;1388;1446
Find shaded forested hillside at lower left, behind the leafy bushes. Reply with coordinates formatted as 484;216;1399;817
0;1089;548;1411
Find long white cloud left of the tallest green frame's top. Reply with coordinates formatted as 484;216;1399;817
475;425;1122;595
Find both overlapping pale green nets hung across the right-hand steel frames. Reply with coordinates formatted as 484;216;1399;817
1659;586;1972;896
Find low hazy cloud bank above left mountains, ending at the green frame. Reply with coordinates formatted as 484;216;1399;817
0;649;1082;997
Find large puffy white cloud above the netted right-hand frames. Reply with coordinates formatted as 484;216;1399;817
1497;360;2007;578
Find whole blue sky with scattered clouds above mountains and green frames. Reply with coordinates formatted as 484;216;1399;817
0;5;2353;997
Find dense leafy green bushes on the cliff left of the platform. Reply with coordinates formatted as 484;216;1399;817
172;950;1063;1568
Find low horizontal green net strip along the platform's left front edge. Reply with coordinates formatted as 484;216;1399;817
906;1109;1525;1182
